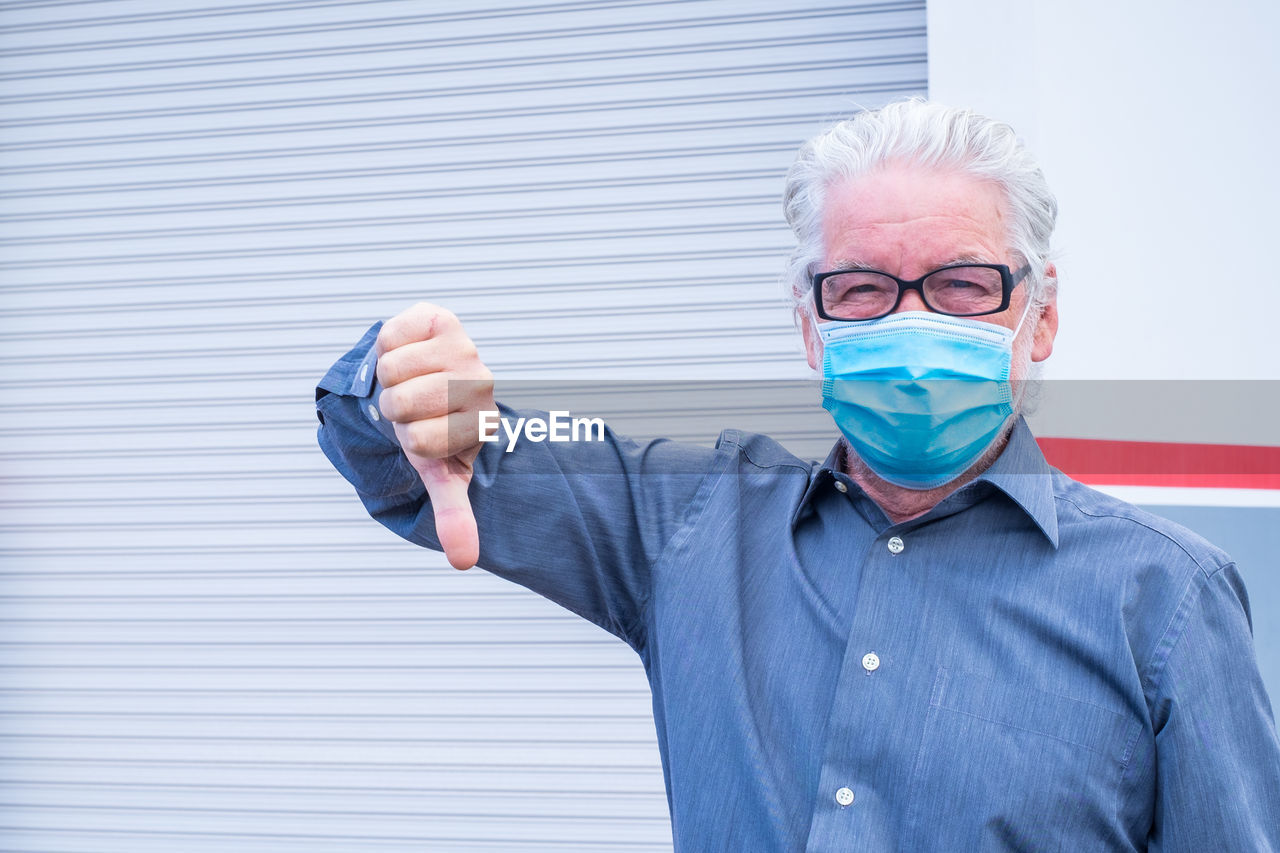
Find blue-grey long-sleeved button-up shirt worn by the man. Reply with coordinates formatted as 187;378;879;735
317;327;1280;853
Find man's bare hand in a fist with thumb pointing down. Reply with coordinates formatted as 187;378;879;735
375;302;497;569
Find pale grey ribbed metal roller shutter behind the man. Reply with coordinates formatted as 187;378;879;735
0;0;925;853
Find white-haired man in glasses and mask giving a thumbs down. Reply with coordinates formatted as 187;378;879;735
317;101;1280;852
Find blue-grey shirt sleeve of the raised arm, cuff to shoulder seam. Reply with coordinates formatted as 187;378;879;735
316;320;717;644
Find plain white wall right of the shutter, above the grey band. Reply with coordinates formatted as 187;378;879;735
928;0;1280;379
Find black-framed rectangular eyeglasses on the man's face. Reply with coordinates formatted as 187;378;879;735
813;264;1032;320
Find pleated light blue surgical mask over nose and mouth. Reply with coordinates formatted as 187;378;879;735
818;311;1025;489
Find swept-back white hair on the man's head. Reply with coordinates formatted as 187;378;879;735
783;97;1057;319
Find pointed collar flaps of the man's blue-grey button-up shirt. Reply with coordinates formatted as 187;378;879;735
791;416;1057;548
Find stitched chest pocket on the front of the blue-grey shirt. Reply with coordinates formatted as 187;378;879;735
902;669;1140;852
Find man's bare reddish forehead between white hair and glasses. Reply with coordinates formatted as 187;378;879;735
823;164;1009;277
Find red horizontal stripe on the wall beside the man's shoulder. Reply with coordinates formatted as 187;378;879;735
1037;438;1280;489
